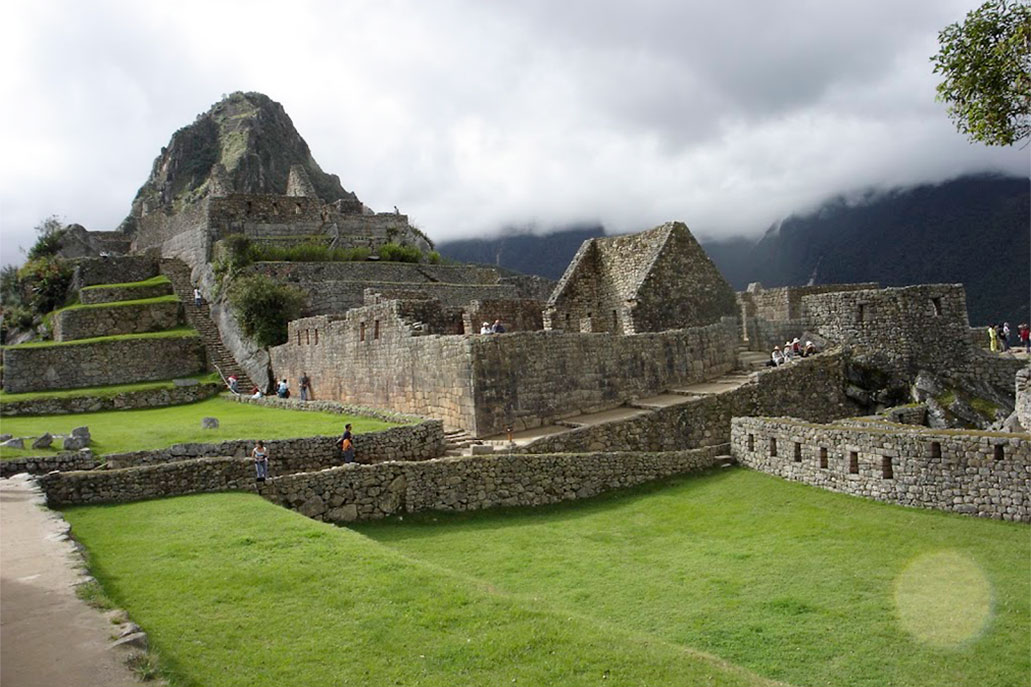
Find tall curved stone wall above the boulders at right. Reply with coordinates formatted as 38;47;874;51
802;284;969;375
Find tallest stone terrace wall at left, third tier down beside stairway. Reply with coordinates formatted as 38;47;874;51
3;334;205;393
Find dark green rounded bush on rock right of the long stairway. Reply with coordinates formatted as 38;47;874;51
229;274;305;347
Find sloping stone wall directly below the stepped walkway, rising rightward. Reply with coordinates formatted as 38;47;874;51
522;352;861;454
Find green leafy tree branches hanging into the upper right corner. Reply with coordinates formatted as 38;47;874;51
931;0;1031;145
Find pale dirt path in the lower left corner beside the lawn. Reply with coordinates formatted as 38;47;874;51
0;477;139;687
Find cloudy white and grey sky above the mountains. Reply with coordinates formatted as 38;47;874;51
0;0;1029;262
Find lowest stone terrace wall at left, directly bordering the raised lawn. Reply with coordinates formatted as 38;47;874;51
0;380;224;417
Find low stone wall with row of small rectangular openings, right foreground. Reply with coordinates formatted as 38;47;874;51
731;418;1031;522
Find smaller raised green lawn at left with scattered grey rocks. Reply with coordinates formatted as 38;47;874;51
0;397;396;459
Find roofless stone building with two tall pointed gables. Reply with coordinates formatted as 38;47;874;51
544;222;736;334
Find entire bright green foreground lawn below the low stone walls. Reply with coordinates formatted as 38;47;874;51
66;469;1031;687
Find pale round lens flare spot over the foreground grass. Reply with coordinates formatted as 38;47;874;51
895;551;992;649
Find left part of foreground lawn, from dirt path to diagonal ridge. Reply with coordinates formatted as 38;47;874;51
65;494;770;687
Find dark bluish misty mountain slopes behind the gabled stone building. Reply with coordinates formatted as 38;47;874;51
438;175;1031;325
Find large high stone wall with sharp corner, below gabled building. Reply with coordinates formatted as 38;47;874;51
271;309;736;436
